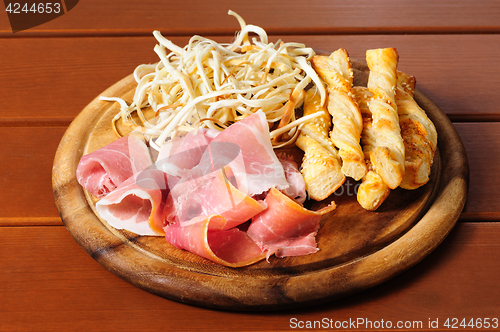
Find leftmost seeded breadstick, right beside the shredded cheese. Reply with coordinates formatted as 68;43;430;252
295;88;345;201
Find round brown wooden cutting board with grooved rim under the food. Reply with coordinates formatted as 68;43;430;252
52;61;469;310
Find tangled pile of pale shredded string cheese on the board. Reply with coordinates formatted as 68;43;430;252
101;11;327;149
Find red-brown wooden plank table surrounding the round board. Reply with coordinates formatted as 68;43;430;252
0;0;500;331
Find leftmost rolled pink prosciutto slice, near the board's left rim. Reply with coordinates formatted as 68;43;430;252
76;135;152;198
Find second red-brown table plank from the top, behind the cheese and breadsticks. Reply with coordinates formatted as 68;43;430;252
0;35;500;126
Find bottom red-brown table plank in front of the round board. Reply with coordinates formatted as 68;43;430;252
0;223;500;331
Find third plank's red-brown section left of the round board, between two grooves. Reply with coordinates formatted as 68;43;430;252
0;127;65;225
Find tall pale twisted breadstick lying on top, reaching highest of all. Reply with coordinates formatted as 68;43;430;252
366;48;405;189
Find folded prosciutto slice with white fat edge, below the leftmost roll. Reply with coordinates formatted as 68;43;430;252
96;169;168;236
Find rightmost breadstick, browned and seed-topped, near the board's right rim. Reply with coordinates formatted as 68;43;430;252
396;72;437;189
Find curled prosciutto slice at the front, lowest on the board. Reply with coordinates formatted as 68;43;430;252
165;215;266;267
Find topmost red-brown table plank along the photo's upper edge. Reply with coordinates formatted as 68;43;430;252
0;0;500;36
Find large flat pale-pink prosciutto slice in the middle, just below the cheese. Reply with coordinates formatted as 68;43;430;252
159;111;288;227
